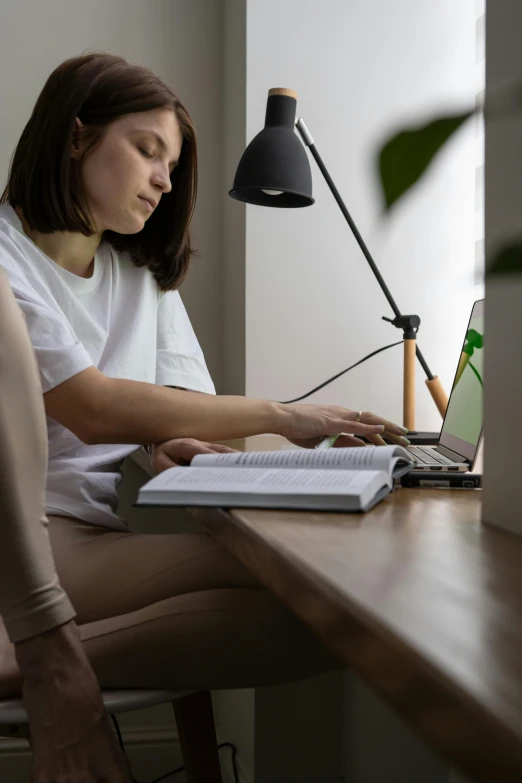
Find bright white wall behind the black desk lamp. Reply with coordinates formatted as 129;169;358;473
246;0;482;429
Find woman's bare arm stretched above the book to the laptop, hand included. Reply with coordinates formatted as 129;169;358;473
44;367;403;445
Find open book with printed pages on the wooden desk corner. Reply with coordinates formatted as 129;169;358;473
136;446;413;511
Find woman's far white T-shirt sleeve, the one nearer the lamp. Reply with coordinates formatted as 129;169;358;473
156;291;216;394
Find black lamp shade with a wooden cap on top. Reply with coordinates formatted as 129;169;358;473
229;94;314;207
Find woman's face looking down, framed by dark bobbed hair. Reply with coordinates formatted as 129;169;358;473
77;109;183;234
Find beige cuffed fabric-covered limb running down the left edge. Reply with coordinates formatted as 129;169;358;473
0;269;75;642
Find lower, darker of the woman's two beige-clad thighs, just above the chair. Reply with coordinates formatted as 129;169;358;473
80;588;342;690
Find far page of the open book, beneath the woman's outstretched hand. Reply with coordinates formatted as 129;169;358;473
191;446;412;474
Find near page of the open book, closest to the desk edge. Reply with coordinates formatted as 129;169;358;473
140;467;391;497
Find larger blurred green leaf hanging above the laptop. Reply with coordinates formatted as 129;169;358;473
378;110;475;210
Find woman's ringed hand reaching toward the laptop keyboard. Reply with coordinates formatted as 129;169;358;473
279;403;409;448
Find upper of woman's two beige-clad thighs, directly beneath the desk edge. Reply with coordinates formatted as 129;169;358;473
49;516;261;623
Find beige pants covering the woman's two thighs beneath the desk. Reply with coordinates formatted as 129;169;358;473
49;516;341;689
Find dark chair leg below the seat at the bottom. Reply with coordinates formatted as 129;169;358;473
173;691;222;783
